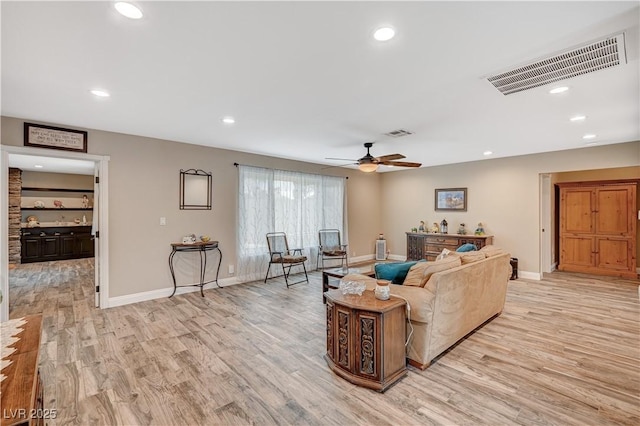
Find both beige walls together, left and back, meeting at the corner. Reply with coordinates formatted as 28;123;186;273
1;117;640;297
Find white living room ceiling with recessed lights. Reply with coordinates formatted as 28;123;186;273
1;1;640;169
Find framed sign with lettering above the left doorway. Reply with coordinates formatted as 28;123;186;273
24;122;87;152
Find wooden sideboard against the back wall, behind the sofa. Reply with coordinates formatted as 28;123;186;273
407;232;493;260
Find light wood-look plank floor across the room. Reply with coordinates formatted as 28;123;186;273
10;259;640;425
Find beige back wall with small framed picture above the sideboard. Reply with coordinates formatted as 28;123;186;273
380;142;640;273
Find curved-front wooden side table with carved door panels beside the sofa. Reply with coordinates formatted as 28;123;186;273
325;290;407;392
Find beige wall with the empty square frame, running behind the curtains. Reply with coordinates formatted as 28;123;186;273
1;117;381;297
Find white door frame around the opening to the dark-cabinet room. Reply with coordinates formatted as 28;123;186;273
0;145;110;322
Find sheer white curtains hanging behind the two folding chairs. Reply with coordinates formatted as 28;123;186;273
237;165;347;280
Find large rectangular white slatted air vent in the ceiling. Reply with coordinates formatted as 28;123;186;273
487;33;627;95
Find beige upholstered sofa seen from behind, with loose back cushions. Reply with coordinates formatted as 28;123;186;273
344;246;511;369
